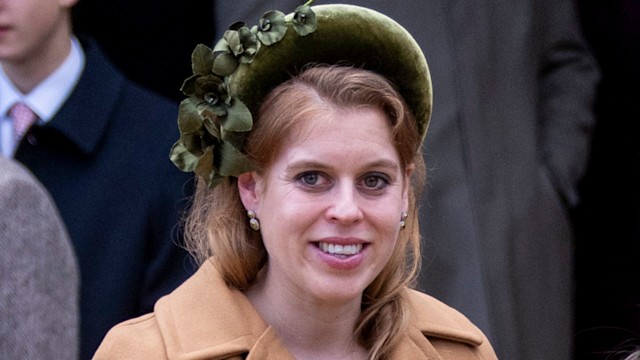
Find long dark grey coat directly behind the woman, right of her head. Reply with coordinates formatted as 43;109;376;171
215;0;598;360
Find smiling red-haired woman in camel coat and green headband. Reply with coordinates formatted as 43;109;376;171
96;5;495;359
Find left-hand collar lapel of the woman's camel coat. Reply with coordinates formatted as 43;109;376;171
154;259;293;359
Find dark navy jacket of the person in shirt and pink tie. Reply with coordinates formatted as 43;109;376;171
15;38;192;358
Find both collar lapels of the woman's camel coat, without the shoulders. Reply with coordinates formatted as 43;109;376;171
154;259;483;360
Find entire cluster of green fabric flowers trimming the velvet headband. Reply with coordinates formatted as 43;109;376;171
170;0;317;187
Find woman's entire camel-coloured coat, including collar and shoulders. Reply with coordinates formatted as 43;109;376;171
94;261;497;360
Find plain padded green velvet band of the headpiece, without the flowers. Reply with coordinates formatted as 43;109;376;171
229;4;433;138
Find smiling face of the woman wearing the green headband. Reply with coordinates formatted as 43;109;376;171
241;108;408;303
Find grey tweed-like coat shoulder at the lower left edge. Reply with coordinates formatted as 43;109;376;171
0;157;79;360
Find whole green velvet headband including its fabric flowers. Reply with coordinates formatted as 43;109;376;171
170;0;432;186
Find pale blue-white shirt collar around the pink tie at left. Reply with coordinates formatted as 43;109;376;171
0;37;85;122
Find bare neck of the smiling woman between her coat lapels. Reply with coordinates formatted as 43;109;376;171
245;273;367;359
